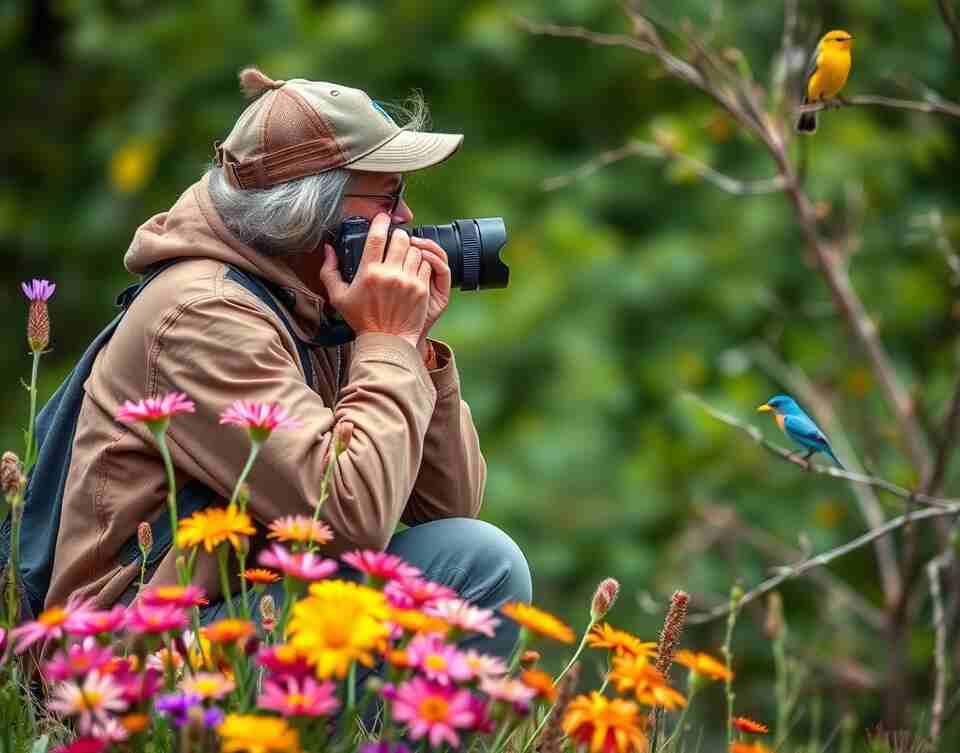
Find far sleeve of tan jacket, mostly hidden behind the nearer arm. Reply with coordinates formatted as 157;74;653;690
402;340;487;525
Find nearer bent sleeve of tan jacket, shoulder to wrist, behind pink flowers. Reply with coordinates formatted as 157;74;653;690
151;294;436;553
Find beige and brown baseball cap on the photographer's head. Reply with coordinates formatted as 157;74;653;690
213;68;463;188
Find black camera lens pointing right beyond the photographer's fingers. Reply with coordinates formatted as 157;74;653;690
410;217;510;290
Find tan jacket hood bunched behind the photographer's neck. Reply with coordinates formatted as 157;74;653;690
123;175;324;328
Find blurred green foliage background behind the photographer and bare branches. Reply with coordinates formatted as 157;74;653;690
0;0;960;750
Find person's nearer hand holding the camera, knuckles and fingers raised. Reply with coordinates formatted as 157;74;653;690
320;213;432;348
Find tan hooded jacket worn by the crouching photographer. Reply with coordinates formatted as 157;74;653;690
46;173;486;606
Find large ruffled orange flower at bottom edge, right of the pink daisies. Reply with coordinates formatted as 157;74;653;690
563;690;647;753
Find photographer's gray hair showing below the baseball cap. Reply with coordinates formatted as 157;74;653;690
208;92;428;256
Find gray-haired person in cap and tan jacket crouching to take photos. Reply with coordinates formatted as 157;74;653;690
46;69;531;656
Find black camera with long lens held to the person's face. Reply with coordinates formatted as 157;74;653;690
333;217;510;290
